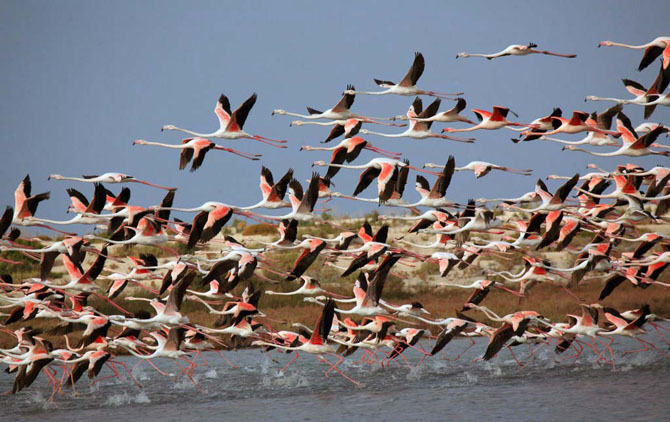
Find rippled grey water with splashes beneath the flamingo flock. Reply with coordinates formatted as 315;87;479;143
0;336;670;422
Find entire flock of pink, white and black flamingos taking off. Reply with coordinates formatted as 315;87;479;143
0;37;670;399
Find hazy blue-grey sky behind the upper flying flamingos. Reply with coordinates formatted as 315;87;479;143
0;0;670;227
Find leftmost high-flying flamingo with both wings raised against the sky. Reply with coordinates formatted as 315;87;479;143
161;94;286;148
